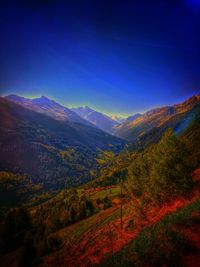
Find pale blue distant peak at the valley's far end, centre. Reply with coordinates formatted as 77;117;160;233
72;106;119;134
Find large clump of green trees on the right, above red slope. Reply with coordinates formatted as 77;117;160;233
126;129;193;202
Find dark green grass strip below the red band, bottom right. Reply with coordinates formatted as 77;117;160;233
98;200;200;267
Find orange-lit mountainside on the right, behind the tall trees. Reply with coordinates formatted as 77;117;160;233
115;95;200;147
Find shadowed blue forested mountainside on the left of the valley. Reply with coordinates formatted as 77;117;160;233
0;98;124;194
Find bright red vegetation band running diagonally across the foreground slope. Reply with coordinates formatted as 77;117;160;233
42;185;200;267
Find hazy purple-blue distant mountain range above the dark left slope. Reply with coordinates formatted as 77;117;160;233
5;95;129;134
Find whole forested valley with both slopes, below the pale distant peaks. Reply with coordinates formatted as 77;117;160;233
0;96;200;267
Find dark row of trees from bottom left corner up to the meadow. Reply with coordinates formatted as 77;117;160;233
0;189;96;266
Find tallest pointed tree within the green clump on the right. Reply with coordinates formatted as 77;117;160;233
147;129;193;201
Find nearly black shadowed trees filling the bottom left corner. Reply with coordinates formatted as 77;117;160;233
0;207;68;267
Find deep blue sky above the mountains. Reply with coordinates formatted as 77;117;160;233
0;0;200;114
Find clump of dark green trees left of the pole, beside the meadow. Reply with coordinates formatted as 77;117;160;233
34;189;95;232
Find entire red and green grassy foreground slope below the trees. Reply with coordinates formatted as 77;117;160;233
1;180;200;267
